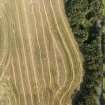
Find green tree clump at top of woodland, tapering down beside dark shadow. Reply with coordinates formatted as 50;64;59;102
65;0;102;43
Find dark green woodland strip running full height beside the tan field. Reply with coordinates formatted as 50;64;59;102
65;0;105;105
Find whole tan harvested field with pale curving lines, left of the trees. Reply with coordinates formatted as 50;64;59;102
0;0;83;105
